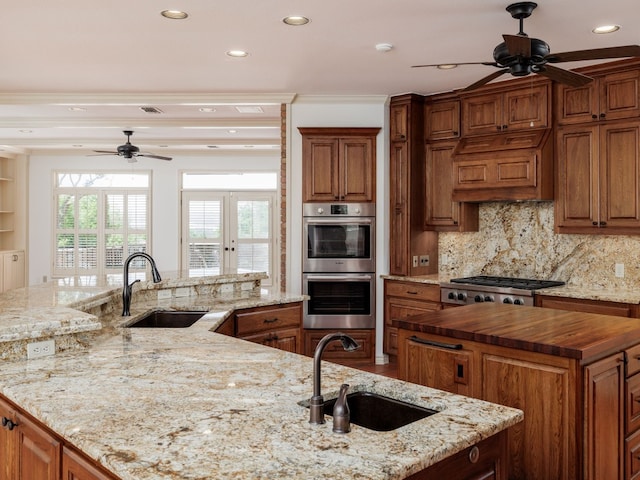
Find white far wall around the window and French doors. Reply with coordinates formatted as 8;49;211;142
28;151;280;285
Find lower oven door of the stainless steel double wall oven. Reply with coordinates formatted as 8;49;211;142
302;273;376;329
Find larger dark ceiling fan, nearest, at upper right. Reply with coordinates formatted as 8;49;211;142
412;2;640;91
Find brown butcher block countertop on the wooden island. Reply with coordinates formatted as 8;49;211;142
393;303;640;363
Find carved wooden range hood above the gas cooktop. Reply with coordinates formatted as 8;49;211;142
452;128;554;202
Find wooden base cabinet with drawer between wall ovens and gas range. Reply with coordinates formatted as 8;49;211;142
383;279;442;356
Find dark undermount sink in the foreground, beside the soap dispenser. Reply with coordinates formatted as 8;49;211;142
316;392;438;432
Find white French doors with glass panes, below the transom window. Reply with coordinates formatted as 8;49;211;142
181;191;277;286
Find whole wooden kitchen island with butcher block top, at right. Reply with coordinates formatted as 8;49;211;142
393;303;640;480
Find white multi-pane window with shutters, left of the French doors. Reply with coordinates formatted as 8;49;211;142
52;172;151;276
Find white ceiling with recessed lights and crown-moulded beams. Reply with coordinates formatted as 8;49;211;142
0;0;640;155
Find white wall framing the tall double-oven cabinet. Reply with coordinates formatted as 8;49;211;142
287;96;389;361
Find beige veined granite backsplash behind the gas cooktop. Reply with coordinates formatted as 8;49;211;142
439;202;640;289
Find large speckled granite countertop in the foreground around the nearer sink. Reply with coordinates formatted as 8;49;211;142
0;314;522;480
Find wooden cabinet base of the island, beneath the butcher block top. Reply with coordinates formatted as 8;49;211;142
398;329;628;480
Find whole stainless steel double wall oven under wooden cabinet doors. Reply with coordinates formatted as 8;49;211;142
302;203;376;328
